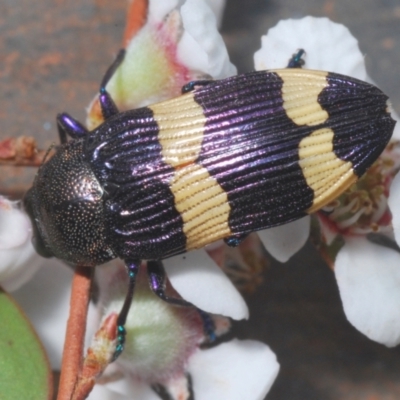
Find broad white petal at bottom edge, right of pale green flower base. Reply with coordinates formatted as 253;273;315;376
188;340;279;400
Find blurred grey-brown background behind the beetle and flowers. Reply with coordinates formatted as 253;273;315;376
0;0;400;400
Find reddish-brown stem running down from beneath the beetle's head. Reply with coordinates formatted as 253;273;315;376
57;266;94;400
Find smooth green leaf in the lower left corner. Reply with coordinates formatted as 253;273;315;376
0;289;53;400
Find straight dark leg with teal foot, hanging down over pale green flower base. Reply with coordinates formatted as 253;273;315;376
113;260;141;361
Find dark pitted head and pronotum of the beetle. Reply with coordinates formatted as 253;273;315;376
24;140;115;266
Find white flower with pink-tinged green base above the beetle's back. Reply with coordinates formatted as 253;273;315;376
87;0;236;129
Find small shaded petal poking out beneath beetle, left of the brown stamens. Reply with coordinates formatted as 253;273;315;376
257;215;310;263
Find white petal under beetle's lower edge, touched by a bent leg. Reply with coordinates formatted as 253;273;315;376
163;250;249;319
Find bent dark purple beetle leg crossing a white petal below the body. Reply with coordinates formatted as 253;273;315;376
147;261;216;342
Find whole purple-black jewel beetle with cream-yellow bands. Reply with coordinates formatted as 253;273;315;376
24;51;395;356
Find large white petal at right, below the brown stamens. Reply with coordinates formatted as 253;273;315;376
335;238;400;347
